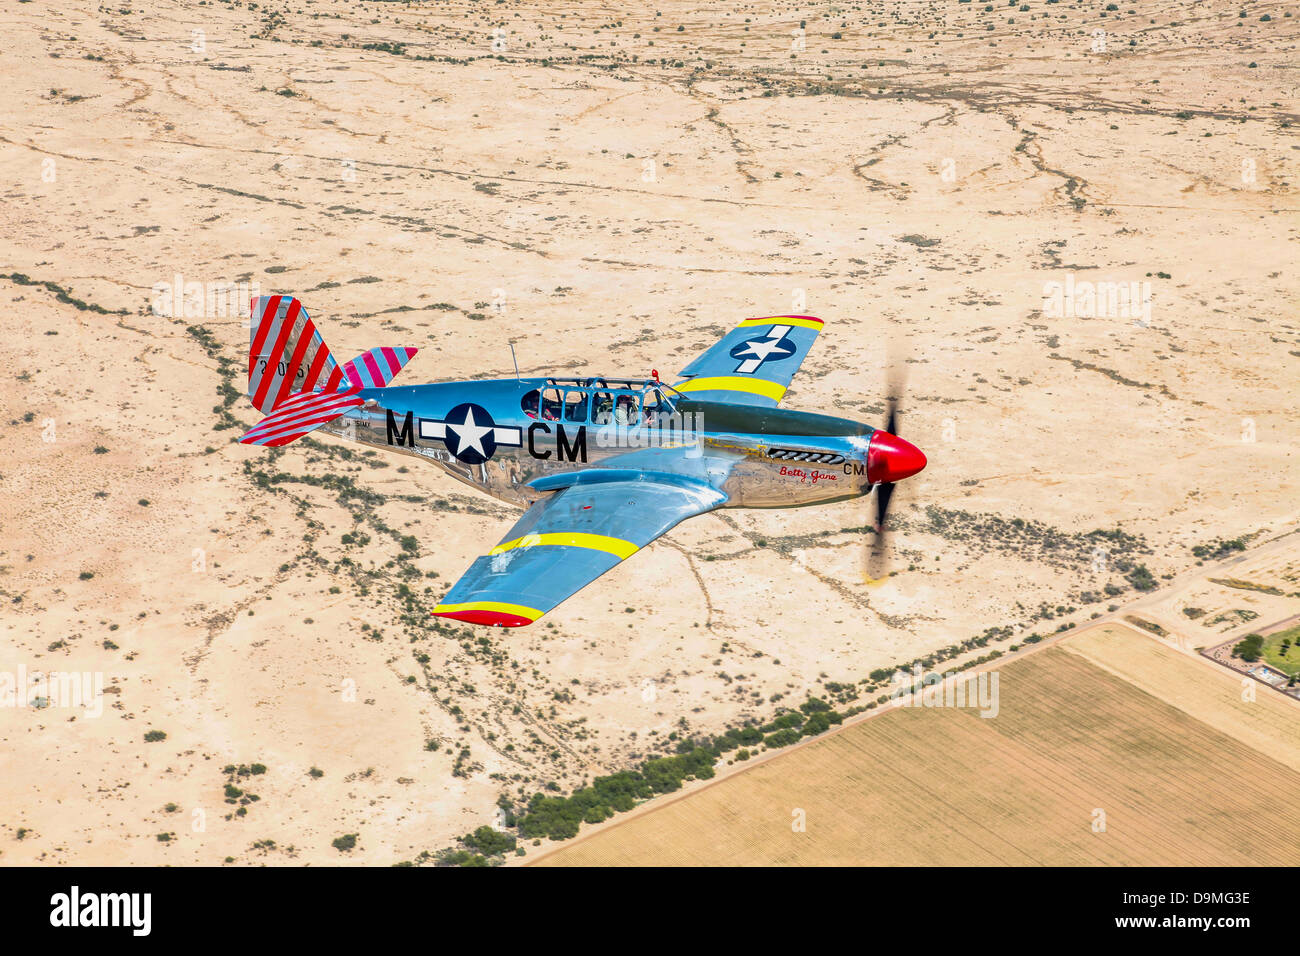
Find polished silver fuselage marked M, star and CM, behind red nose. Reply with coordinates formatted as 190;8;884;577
321;377;884;507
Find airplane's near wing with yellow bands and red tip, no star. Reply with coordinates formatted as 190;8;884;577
433;470;727;627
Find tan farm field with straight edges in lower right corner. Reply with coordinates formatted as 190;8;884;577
541;626;1300;866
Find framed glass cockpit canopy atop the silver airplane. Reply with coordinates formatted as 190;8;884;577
520;377;679;428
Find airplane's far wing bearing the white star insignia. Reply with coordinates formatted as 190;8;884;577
673;315;822;407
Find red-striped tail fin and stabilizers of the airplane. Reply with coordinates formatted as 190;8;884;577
239;295;417;445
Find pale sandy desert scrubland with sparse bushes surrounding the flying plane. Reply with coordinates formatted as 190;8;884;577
0;0;1300;864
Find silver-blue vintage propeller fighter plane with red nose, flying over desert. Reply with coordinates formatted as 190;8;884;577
239;295;926;627
